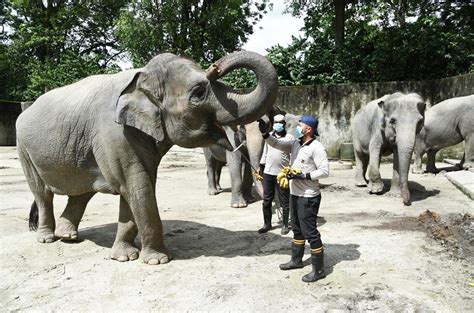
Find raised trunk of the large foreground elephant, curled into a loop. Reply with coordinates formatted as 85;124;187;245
206;51;278;126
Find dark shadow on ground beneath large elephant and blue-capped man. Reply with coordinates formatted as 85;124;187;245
80;220;360;273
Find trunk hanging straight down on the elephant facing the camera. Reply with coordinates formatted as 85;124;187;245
397;131;415;205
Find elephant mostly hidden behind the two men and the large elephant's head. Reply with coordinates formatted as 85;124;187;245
203;122;264;208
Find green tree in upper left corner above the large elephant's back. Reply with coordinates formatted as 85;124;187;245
0;0;127;100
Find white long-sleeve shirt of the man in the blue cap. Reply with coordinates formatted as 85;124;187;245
265;136;329;197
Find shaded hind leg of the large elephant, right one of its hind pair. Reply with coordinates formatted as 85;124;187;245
54;192;95;241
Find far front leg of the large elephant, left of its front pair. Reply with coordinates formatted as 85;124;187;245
110;196;140;262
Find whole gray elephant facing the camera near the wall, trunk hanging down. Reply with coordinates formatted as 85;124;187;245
352;92;426;205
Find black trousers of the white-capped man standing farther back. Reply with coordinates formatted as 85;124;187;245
262;173;290;226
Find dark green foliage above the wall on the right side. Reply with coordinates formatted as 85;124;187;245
268;0;474;85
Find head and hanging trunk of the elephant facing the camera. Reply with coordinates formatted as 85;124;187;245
378;93;426;205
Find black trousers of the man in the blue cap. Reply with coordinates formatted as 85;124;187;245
290;195;323;249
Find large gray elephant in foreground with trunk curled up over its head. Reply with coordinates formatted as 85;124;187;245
17;51;278;264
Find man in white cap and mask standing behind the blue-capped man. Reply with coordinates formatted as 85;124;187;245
258;114;294;235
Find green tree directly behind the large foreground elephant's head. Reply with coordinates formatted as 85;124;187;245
118;0;271;66
